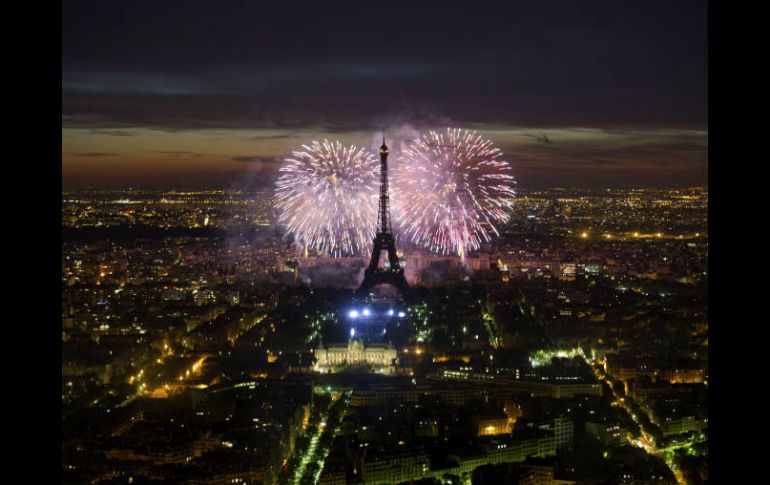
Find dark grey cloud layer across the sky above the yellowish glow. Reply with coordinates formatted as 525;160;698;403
62;0;706;129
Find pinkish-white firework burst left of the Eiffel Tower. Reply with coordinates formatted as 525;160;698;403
275;140;380;256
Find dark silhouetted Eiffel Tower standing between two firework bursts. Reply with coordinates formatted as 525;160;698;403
356;136;409;299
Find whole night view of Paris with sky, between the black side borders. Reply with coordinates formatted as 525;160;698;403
61;1;704;485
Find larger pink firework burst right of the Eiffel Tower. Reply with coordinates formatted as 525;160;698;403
393;128;516;257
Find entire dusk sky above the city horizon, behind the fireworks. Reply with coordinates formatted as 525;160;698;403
62;0;708;189
